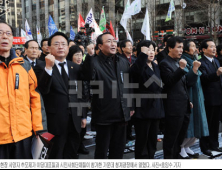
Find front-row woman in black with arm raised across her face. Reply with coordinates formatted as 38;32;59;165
130;41;165;159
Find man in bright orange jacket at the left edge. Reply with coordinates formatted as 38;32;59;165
0;22;47;159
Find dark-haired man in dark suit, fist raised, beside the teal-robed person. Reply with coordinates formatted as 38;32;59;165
160;37;200;159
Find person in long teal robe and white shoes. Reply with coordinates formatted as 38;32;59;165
180;40;209;159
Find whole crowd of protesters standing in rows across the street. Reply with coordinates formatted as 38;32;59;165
0;22;222;159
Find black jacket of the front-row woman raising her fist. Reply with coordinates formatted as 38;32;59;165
130;53;165;119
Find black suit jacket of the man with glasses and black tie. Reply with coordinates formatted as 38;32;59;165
39;61;86;135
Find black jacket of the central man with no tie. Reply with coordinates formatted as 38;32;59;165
82;52;130;124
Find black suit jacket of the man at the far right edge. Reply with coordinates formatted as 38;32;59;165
200;56;222;106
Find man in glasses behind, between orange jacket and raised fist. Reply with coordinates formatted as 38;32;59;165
24;40;45;80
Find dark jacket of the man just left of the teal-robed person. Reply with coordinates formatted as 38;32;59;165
160;56;198;116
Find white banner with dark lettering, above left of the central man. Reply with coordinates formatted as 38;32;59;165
85;9;102;42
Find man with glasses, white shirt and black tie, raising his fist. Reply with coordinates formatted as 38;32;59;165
39;32;86;159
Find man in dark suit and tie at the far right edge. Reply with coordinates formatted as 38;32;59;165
200;39;222;156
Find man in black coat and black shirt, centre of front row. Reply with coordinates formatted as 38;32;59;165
83;33;133;159
